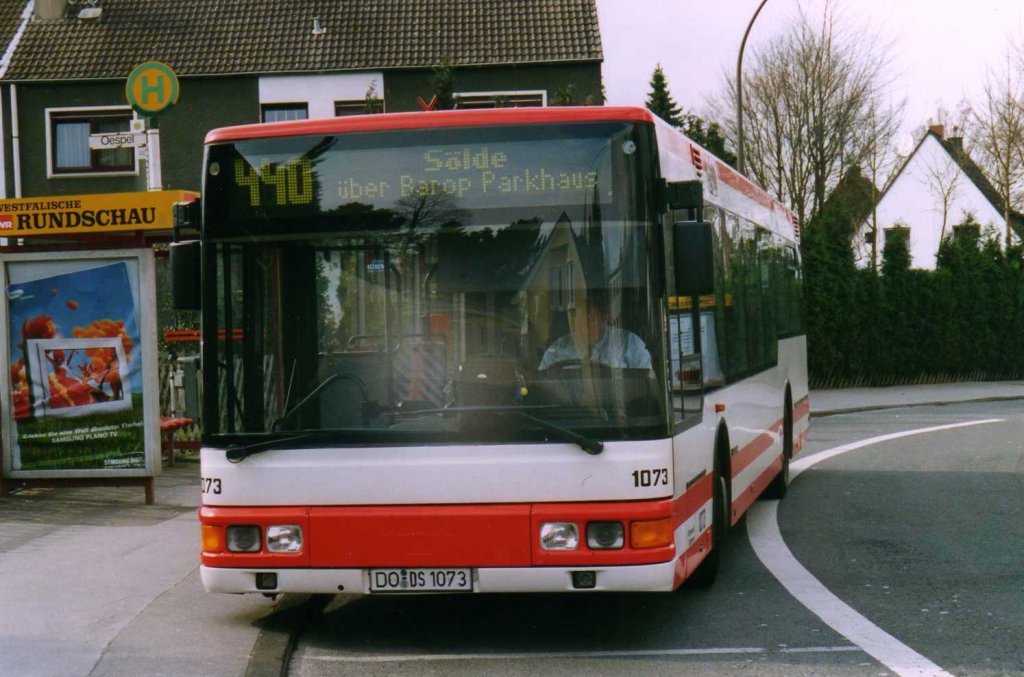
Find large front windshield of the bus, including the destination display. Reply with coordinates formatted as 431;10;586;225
204;123;669;443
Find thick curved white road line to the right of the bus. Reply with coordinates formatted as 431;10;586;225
746;419;1004;677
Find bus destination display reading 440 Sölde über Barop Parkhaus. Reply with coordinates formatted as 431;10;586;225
217;133;612;215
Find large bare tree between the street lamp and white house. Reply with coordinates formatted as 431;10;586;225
714;2;901;227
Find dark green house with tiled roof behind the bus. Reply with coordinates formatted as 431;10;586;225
0;0;602;198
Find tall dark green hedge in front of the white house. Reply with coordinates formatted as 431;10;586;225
802;218;1024;387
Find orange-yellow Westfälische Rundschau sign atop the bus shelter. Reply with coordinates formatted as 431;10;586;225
0;191;198;238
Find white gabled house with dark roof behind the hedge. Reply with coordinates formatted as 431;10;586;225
857;125;1024;269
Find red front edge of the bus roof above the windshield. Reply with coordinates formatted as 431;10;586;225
206;107;654;143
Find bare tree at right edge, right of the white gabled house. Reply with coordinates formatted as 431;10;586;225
972;54;1024;247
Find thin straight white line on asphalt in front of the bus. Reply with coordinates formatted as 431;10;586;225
302;646;860;663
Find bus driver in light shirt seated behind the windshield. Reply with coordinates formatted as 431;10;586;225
538;290;651;371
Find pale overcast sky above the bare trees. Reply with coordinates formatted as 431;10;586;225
597;0;1024;144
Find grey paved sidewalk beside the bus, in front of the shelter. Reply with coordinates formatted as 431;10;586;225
0;457;276;677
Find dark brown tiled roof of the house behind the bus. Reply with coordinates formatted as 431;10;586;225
0;0;602;81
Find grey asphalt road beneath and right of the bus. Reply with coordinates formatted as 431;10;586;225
289;403;1024;677
